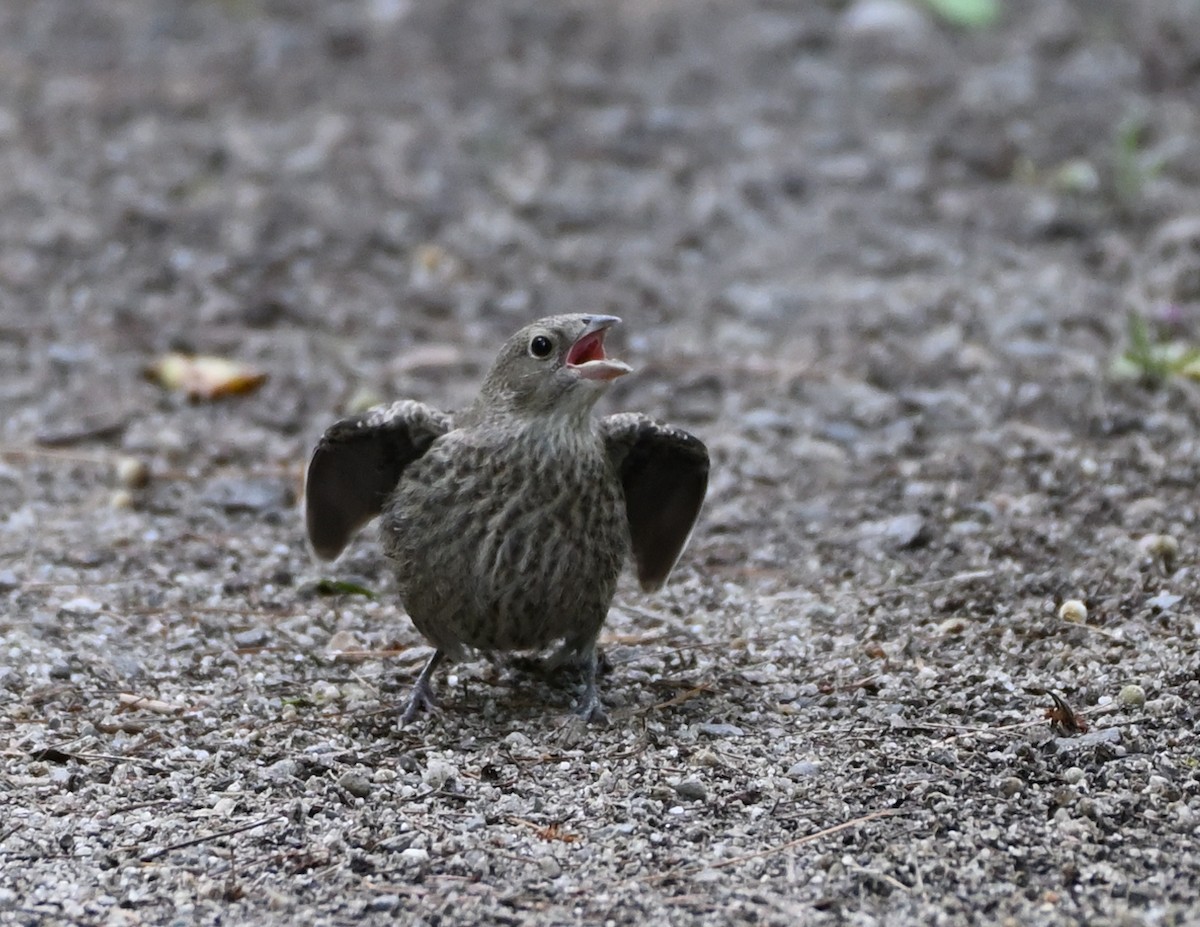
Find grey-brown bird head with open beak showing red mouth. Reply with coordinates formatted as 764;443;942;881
480;315;630;414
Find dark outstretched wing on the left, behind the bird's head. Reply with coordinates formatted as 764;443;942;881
305;400;454;560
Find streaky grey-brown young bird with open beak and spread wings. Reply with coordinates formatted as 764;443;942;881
305;313;709;724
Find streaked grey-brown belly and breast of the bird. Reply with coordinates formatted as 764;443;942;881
384;437;629;657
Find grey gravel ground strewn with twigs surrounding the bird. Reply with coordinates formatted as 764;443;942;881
0;0;1200;925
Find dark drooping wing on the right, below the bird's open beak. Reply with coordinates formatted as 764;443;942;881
600;413;708;590
